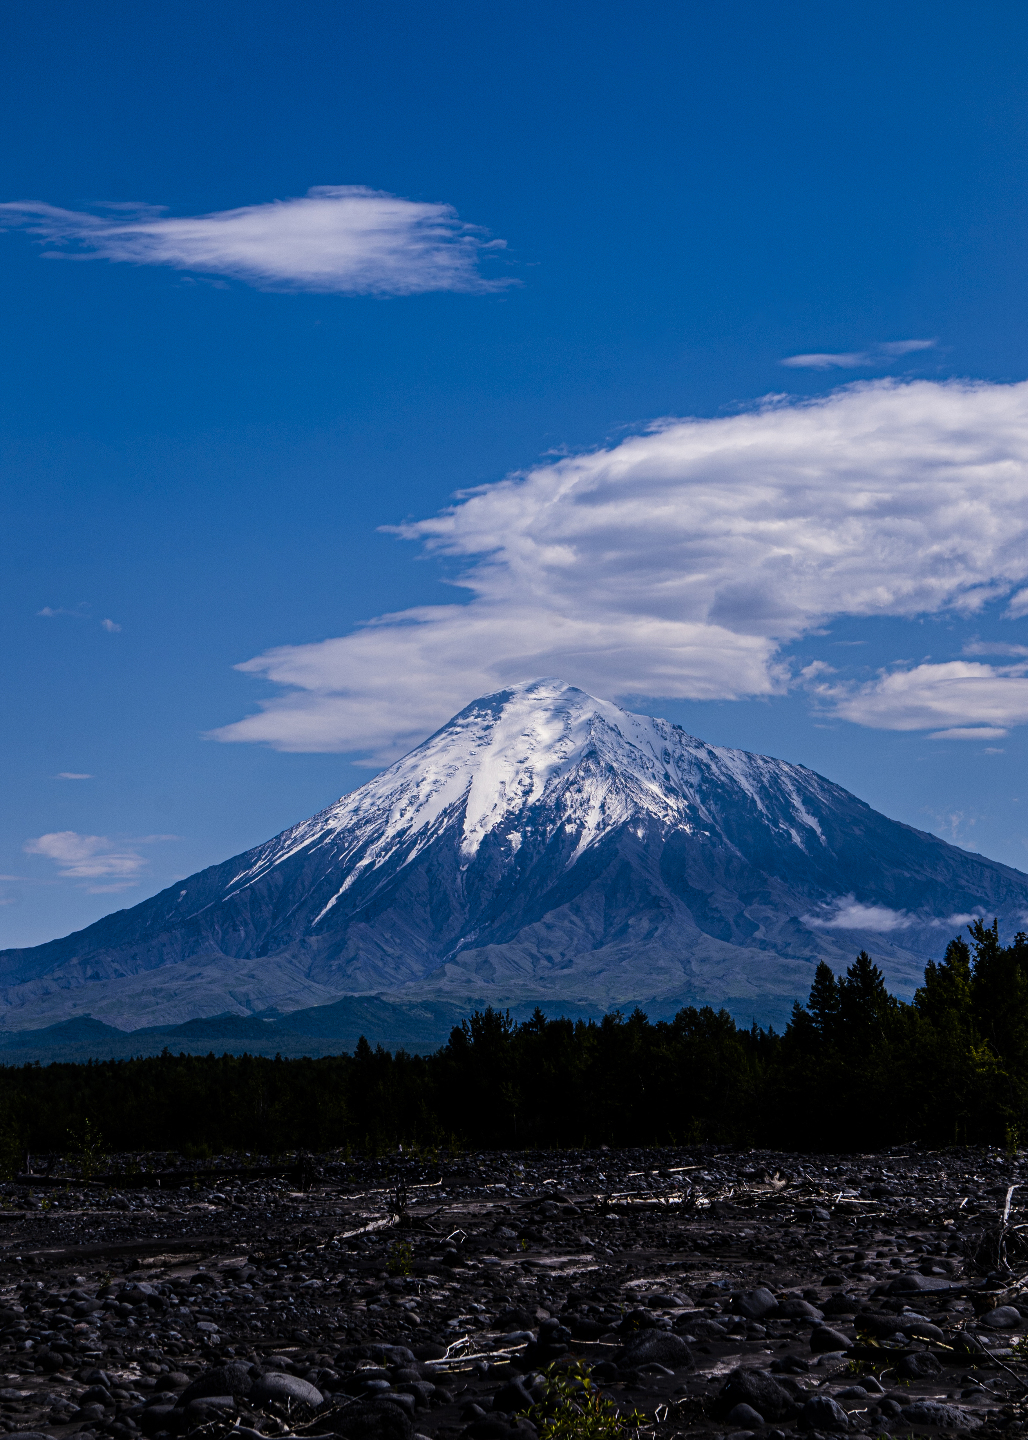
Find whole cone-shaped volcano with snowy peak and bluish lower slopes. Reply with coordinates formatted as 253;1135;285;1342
0;680;1028;1027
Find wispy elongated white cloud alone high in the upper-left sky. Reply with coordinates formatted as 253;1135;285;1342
0;186;507;295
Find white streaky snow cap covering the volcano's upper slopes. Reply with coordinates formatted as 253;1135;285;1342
221;680;826;914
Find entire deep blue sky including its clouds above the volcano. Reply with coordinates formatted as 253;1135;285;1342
0;0;1028;946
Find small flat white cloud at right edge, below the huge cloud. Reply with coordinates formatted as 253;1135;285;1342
813;660;1028;740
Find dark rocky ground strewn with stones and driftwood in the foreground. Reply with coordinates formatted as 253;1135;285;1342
0;1148;1028;1440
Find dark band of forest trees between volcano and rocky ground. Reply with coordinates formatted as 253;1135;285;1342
0;920;1028;1157
